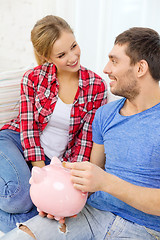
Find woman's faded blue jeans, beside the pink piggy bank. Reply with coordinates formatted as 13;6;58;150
0;130;48;233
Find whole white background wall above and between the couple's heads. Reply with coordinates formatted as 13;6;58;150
0;0;160;78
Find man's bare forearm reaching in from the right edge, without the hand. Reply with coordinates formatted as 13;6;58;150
101;173;160;216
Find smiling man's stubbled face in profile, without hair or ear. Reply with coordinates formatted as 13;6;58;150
107;44;139;99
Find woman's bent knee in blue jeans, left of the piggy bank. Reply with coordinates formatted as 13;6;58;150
0;136;33;213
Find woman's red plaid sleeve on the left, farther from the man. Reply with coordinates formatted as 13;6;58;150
20;72;45;161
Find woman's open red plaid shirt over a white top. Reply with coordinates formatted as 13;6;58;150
2;63;107;162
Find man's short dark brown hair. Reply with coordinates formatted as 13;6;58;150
114;27;160;81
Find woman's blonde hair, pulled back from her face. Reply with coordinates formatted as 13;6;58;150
31;15;73;65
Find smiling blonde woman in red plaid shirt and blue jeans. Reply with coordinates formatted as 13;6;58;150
0;15;107;232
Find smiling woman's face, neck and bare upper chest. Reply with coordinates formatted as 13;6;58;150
49;31;80;104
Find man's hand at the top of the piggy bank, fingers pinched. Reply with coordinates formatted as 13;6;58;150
62;162;105;192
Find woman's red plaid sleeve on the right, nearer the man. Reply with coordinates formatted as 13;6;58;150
63;68;107;162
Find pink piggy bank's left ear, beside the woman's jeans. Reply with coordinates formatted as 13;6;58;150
29;167;46;184
